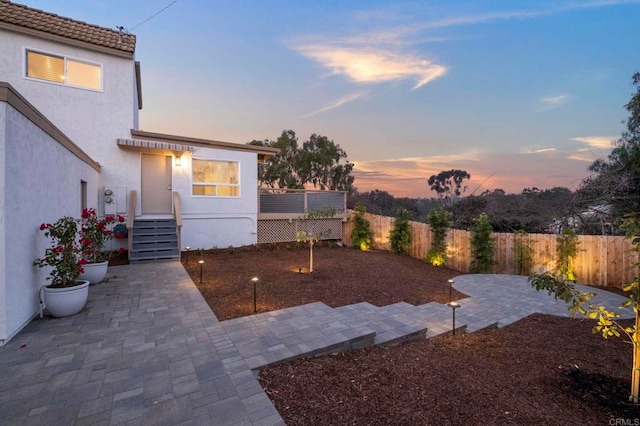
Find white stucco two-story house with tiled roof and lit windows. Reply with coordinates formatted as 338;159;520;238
0;0;276;345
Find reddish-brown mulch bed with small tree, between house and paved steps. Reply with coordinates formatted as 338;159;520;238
182;242;465;321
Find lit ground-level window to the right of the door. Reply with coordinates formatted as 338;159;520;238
191;158;240;197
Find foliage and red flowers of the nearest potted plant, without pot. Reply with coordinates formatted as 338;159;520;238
33;216;87;288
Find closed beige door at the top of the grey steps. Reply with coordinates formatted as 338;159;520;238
140;154;171;215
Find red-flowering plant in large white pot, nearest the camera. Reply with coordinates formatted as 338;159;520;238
34;216;89;317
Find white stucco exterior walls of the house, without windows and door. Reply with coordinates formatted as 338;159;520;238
0;6;272;345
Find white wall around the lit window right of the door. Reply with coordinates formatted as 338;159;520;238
173;147;258;249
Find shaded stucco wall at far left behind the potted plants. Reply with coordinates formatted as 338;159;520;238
0;102;99;341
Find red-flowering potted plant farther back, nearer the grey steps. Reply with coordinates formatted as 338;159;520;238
80;208;124;284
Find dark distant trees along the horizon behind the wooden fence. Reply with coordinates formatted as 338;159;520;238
249;73;640;235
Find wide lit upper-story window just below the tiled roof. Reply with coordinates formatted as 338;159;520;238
25;50;102;90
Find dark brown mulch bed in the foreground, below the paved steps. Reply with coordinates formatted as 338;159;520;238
260;314;640;425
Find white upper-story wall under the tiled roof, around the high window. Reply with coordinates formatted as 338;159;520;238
0;30;140;207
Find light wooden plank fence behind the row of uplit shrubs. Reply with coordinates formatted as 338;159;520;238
342;213;639;287
